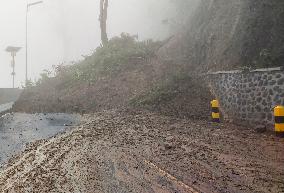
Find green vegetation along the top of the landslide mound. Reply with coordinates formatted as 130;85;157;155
37;33;162;87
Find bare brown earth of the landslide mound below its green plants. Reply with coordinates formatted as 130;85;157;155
13;58;213;119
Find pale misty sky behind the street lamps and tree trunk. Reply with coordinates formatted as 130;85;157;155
0;0;173;88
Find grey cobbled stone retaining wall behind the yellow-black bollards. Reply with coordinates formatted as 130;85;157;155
207;68;284;125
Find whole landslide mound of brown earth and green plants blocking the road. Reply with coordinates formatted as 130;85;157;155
14;34;211;118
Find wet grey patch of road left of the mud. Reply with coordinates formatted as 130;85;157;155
0;112;82;166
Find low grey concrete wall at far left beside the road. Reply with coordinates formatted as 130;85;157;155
0;88;22;104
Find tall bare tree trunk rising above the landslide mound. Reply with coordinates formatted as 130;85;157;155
100;0;108;46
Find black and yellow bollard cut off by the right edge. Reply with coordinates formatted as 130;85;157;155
274;106;284;137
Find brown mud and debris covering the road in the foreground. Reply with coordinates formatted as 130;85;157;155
0;111;284;193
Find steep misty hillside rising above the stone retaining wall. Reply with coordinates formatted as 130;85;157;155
159;0;284;72
